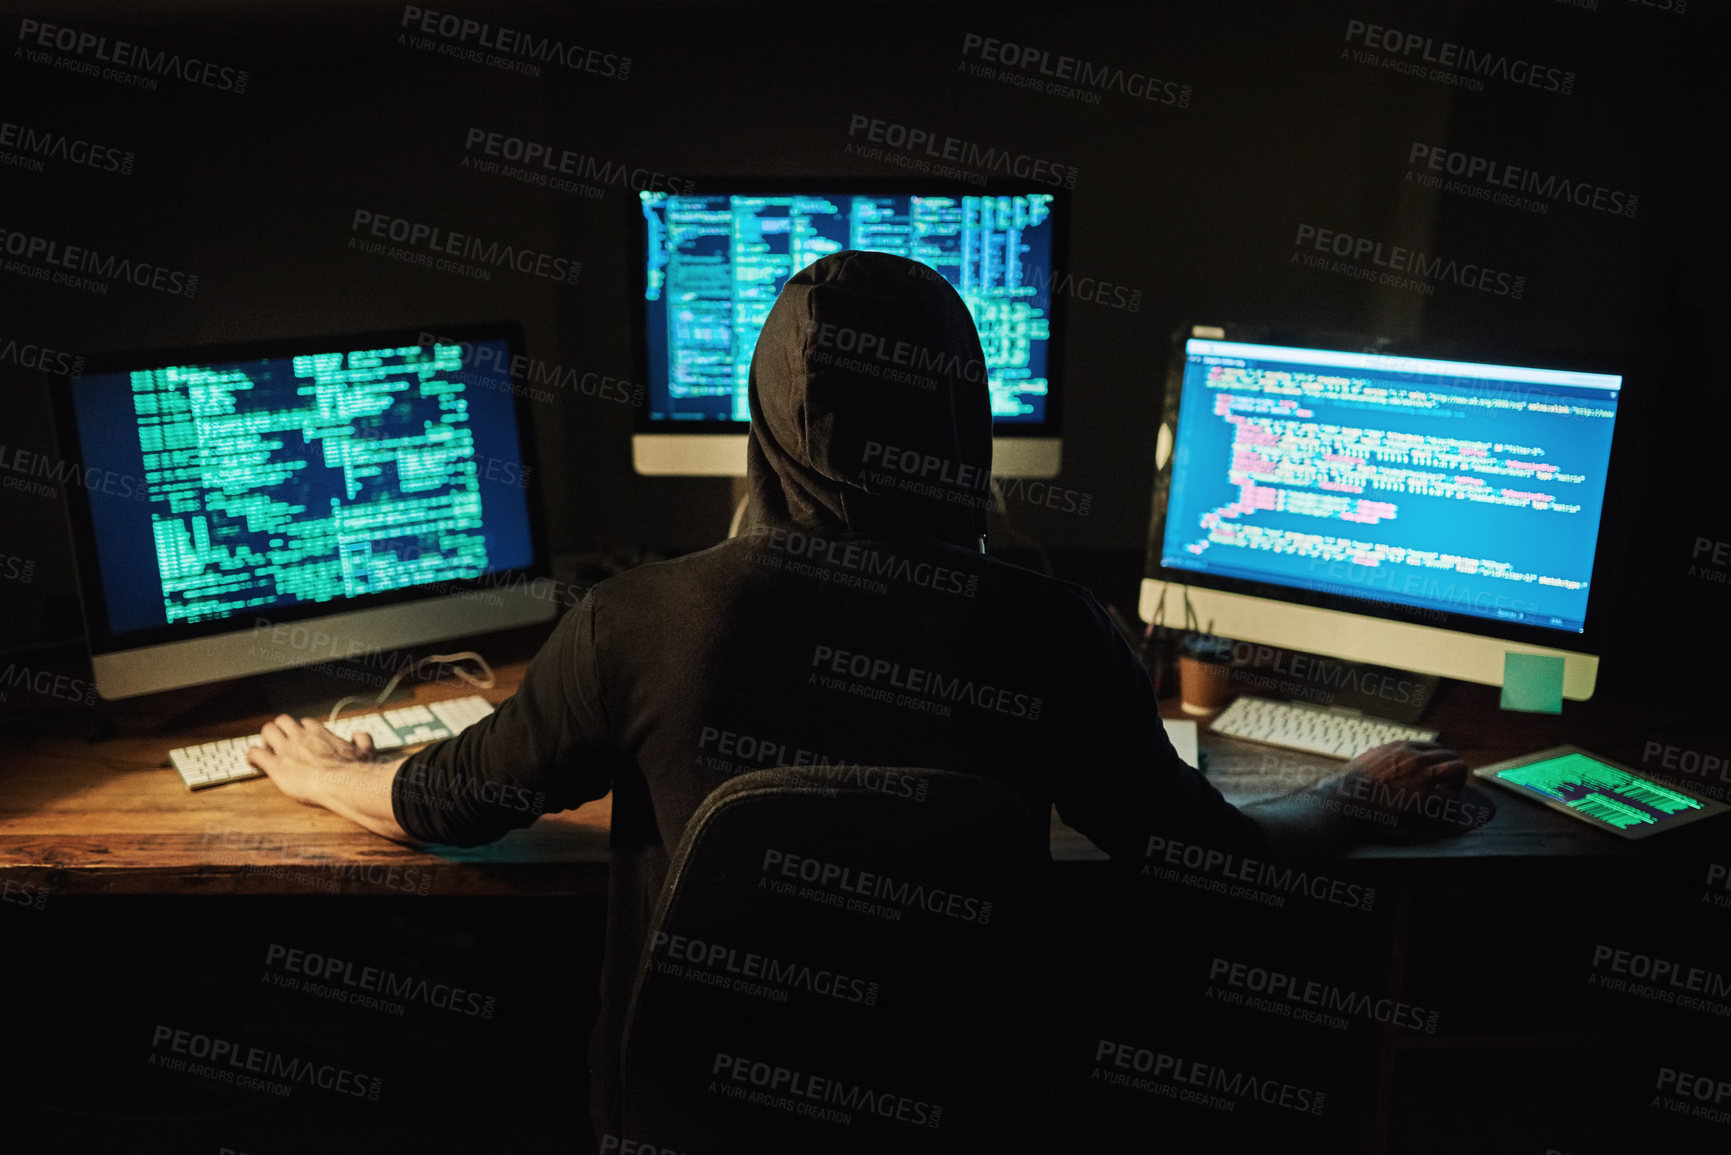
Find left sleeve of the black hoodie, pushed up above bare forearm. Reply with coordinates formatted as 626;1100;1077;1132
391;594;613;847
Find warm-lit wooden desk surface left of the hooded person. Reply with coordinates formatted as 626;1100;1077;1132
0;661;613;897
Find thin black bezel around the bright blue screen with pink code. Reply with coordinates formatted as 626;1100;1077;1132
1142;324;1629;656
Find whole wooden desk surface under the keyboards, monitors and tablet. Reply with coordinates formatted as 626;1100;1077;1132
0;661;1731;895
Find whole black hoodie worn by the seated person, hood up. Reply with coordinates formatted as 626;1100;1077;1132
393;251;1264;1126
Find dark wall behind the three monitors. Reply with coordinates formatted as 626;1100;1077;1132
0;0;1731;668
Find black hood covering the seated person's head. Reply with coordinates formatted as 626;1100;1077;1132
746;249;992;549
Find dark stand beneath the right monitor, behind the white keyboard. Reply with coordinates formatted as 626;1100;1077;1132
1227;642;1442;726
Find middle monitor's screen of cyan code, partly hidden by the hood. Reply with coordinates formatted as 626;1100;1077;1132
639;190;1056;431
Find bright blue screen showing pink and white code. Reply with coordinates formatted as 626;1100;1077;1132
1162;338;1622;636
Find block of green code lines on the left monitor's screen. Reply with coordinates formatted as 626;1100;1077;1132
130;345;488;622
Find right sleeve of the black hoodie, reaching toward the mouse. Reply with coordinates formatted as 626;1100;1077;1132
1052;597;1267;866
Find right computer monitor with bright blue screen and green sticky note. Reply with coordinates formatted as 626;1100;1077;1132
1141;327;1622;700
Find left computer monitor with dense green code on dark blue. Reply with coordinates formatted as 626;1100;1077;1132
55;324;557;698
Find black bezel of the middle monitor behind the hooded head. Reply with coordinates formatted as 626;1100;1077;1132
627;175;1070;440
